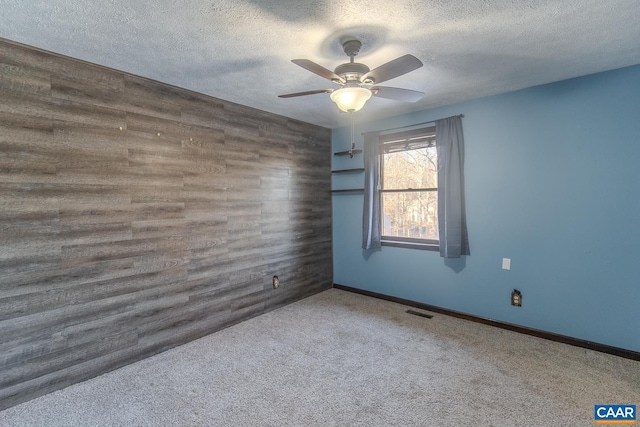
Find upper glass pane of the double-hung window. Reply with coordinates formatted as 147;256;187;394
382;147;438;190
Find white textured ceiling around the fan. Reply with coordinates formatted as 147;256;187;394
0;0;640;128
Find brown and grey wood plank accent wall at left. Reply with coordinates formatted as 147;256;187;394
0;39;332;409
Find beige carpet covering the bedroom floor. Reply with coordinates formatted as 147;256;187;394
0;289;640;426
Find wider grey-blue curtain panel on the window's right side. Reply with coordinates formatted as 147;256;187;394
436;116;470;258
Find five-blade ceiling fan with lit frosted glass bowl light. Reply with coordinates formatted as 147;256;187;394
279;40;424;112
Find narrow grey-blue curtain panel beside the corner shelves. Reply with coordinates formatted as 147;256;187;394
362;132;381;249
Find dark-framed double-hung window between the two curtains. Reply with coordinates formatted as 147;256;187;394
380;127;439;250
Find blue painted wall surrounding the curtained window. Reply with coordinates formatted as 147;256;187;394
332;66;640;351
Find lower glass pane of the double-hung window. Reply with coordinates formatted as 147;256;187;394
382;191;438;240
